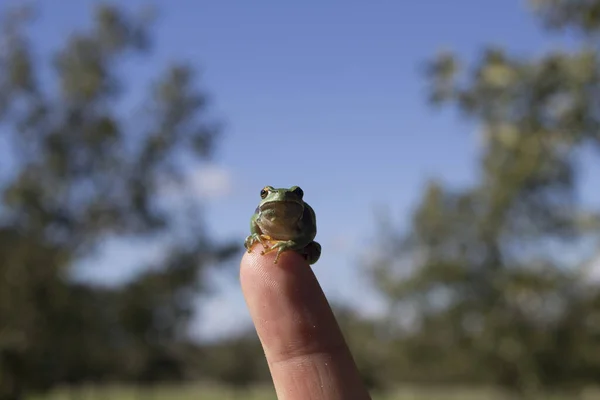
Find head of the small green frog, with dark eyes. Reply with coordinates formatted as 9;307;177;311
256;186;304;222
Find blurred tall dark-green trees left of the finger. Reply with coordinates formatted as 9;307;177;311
0;5;237;400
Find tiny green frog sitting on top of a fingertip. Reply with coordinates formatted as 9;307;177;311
244;186;321;265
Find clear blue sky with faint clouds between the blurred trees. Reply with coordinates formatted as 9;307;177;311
12;0;600;335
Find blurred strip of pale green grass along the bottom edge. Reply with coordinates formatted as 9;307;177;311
28;384;600;400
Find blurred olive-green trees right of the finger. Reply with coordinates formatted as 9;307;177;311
369;0;600;394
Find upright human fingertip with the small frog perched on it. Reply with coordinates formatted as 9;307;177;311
240;245;370;400
